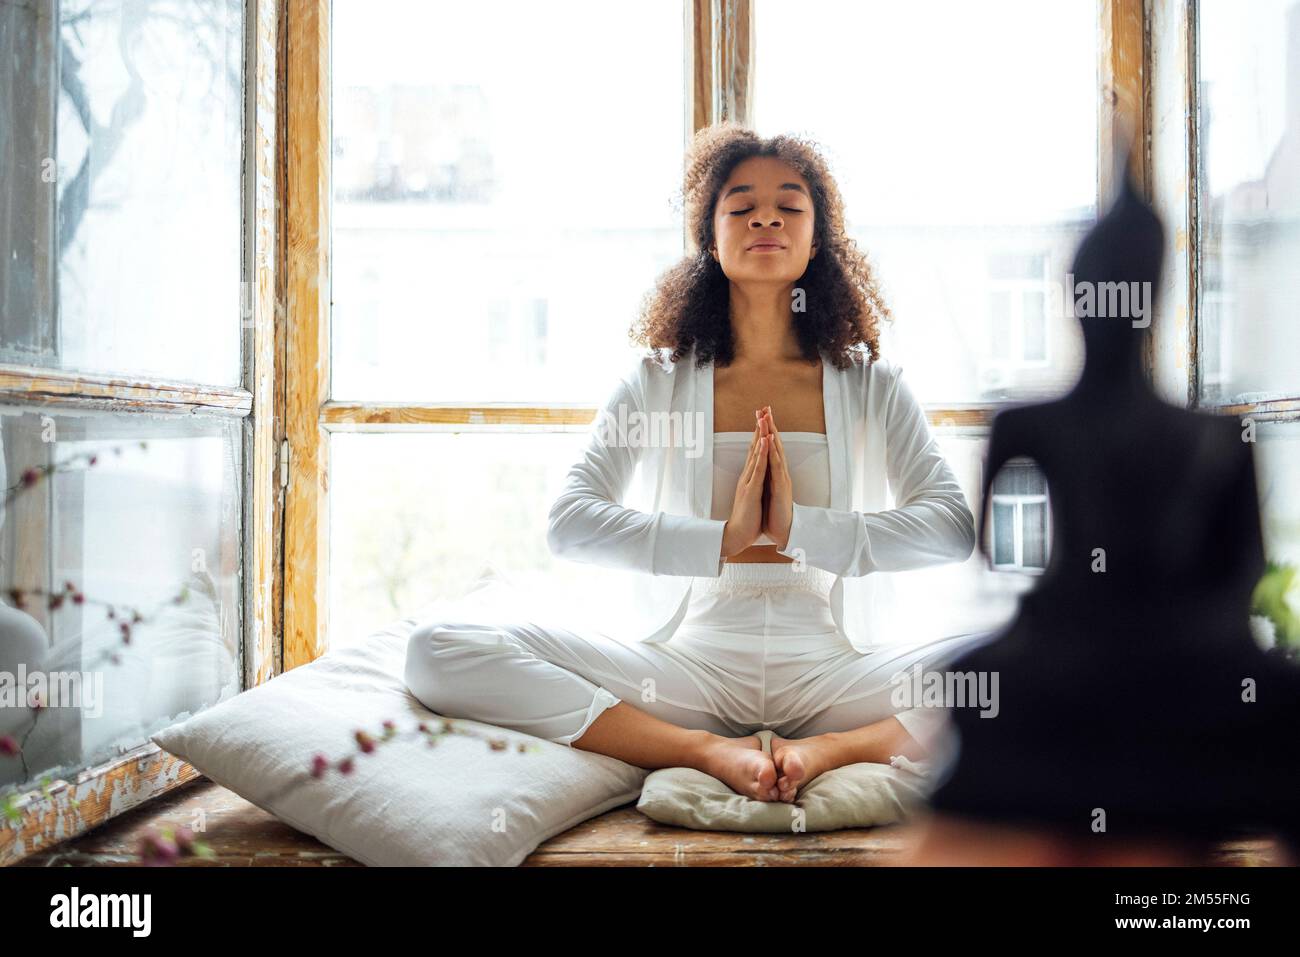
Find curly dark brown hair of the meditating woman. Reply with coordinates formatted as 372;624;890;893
628;122;893;369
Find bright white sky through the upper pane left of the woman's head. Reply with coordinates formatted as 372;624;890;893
333;0;685;228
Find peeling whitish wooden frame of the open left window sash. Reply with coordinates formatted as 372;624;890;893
0;0;287;866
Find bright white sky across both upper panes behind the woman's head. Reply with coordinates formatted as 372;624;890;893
333;0;1128;225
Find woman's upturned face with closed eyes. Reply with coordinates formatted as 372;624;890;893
712;156;816;282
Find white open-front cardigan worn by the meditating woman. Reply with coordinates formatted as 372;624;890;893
547;340;975;653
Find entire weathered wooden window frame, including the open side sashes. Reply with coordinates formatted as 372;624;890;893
0;0;1258;863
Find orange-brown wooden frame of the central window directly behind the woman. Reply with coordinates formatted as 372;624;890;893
283;0;1154;668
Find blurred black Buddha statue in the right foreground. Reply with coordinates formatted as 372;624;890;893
931;141;1300;849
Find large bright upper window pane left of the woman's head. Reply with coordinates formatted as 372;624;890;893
330;0;685;403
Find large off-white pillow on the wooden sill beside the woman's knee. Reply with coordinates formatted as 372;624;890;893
152;599;647;867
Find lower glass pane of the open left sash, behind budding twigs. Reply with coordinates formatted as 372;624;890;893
0;407;242;785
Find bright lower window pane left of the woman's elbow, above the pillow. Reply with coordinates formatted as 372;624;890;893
329;432;592;648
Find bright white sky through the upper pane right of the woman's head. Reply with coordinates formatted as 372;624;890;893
754;0;1097;225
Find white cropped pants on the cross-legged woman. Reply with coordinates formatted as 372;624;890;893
406;563;988;758
